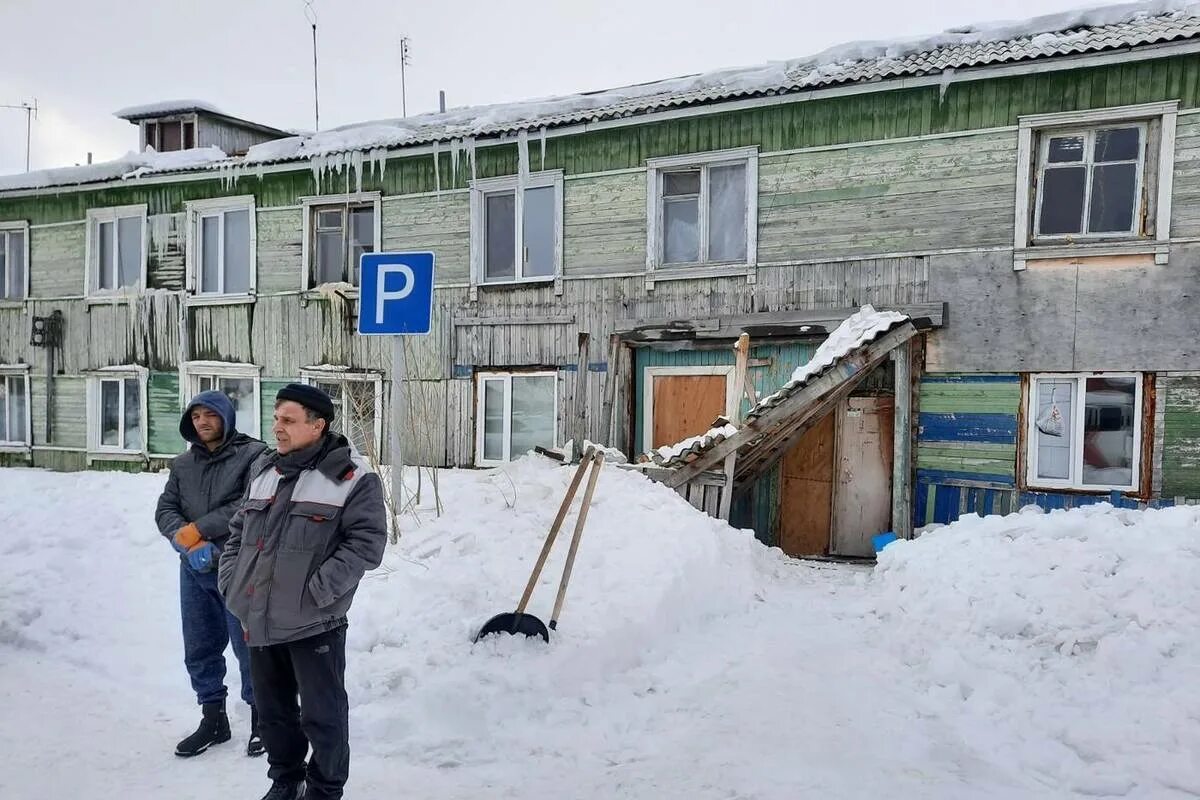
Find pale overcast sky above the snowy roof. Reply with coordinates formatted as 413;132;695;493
0;0;1100;174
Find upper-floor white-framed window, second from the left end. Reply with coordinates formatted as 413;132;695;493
88;205;146;296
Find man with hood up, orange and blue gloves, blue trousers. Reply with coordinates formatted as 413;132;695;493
156;391;266;757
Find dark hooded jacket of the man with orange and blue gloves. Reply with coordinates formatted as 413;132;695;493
155;391;266;549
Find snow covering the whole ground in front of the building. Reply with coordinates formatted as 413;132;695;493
0;458;1200;800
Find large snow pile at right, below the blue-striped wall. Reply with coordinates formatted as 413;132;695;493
874;505;1200;798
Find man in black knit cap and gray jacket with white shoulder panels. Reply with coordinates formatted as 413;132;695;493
220;384;388;800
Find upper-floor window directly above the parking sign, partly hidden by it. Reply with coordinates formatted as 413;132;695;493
304;193;382;289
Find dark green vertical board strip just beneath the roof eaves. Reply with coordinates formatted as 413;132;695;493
0;55;1200;223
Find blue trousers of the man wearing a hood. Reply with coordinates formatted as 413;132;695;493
179;560;254;705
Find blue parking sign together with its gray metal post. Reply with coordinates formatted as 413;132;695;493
359;252;433;534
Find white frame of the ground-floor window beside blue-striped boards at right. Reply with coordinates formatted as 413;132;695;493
1025;372;1146;493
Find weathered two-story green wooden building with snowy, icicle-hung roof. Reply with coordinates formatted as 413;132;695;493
0;8;1200;553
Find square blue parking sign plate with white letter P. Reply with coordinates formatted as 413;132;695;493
359;252;433;336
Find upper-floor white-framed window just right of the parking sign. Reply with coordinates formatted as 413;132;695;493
470;170;563;283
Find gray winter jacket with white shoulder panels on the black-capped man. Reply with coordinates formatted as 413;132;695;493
217;434;388;646
